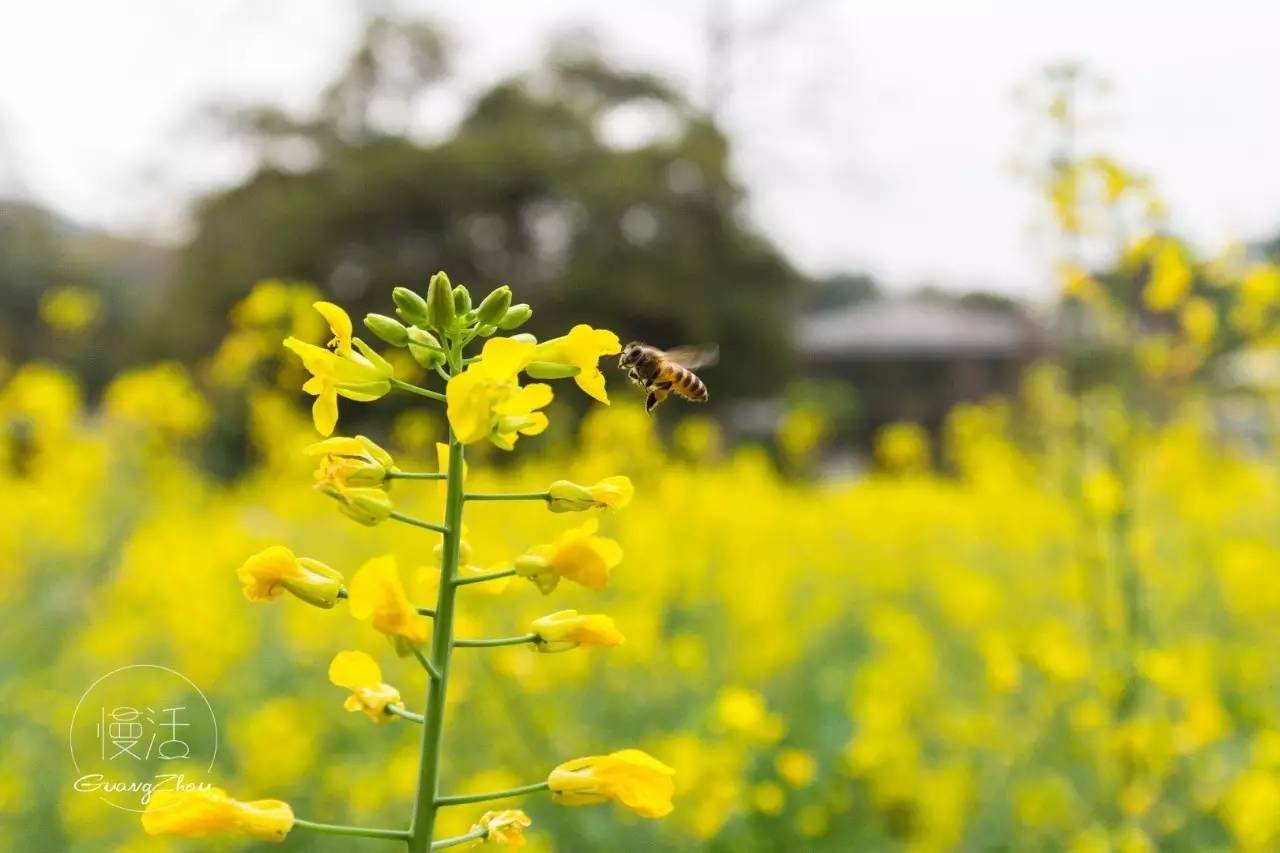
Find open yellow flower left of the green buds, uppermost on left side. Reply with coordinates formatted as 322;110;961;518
284;302;394;435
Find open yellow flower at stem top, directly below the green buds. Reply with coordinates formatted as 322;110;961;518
444;338;553;450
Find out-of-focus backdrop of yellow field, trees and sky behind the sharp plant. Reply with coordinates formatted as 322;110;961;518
0;0;1280;852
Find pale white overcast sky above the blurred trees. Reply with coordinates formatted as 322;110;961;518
0;0;1280;296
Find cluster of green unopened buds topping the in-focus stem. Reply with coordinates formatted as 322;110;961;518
365;273;534;370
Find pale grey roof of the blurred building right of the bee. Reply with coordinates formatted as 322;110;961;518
799;298;1039;360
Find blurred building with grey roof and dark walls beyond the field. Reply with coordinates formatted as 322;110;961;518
797;297;1051;438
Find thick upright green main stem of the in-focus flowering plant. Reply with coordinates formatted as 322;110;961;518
408;425;465;853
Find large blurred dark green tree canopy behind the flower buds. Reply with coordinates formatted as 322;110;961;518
163;18;799;397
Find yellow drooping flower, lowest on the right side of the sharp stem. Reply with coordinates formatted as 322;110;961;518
547;749;676;817
